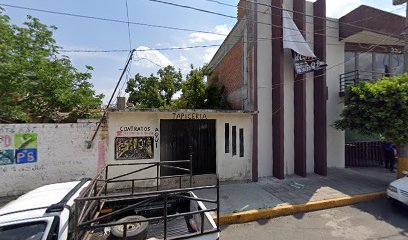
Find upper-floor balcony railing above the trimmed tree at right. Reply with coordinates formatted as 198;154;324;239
340;70;392;96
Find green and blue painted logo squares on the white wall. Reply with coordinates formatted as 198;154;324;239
0;133;38;165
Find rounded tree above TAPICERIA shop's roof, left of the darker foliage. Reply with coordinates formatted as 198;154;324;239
126;66;183;108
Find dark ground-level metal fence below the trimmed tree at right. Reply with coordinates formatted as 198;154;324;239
345;142;384;167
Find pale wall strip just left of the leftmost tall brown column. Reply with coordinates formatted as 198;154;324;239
257;0;273;177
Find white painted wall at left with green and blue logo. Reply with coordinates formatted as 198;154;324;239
0;123;104;196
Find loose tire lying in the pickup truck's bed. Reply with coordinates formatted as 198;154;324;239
111;215;149;240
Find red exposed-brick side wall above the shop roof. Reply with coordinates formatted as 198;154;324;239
210;40;243;110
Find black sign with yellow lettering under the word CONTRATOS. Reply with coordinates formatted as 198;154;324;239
115;136;154;160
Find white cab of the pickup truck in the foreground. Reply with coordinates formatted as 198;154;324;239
0;179;90;240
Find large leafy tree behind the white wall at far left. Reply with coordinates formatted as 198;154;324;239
0;8;103;122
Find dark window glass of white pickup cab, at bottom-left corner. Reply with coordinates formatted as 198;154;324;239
0;222;47;240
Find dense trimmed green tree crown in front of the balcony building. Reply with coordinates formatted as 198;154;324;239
335;74;408;144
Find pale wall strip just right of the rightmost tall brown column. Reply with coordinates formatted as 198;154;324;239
326;19;345;168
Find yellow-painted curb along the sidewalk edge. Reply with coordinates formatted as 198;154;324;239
214;192;386;225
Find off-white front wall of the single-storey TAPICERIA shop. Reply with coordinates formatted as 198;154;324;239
108;110;252;184
